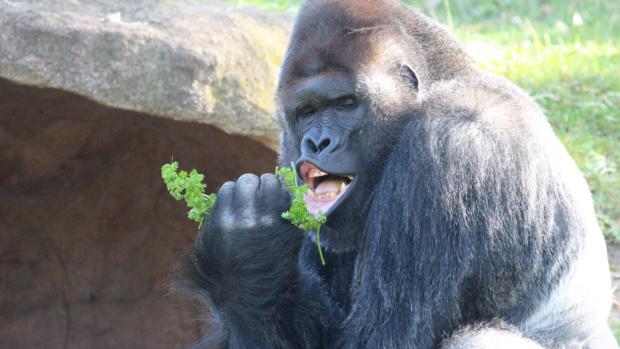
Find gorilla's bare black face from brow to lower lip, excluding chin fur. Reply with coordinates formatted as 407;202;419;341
286;73;367;216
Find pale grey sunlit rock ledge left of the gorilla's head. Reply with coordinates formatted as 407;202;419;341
0;0;292;148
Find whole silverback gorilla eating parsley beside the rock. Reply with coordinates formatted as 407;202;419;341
184;0;617;349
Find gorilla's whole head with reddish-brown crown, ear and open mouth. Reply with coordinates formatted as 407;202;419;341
278;0;470;251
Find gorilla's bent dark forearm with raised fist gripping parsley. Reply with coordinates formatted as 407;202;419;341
184;174;334;348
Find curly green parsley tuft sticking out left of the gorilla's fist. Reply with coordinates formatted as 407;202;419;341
161;161;216;227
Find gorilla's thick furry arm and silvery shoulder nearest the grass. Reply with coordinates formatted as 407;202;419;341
345;77;583;349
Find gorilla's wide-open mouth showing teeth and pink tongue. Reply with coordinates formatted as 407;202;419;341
299;162;354;217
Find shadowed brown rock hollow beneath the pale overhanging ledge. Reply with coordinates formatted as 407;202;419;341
0;79;276;349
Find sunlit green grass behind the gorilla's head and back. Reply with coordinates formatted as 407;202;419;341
230;0;620;243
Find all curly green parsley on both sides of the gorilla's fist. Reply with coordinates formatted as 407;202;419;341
161;161;326;265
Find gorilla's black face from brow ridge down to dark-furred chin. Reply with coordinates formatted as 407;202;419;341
282;73;375;249
